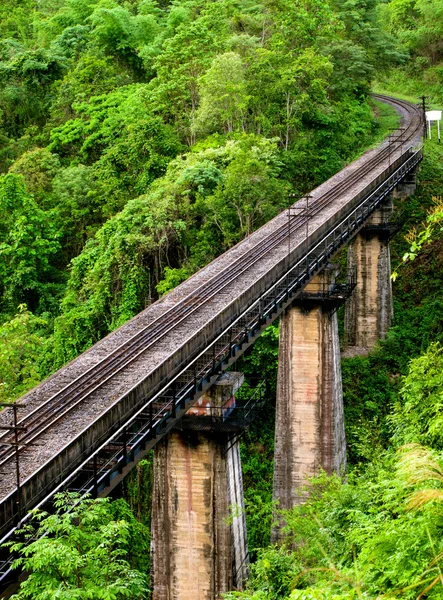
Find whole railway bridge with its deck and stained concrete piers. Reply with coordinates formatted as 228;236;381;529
0;96;423;600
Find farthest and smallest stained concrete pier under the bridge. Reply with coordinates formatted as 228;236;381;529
345;197;393;354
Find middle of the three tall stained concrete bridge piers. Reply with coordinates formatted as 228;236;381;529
271;269;346;542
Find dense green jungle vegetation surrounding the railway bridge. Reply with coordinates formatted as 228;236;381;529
0;0;443;600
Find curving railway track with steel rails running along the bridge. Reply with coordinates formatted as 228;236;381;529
0;96;421;490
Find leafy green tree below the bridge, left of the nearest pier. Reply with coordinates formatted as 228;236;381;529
11;494;148;600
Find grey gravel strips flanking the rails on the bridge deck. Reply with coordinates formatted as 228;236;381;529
0;95;421;525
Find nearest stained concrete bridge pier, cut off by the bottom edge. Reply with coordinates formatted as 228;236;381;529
152;373;248;600
